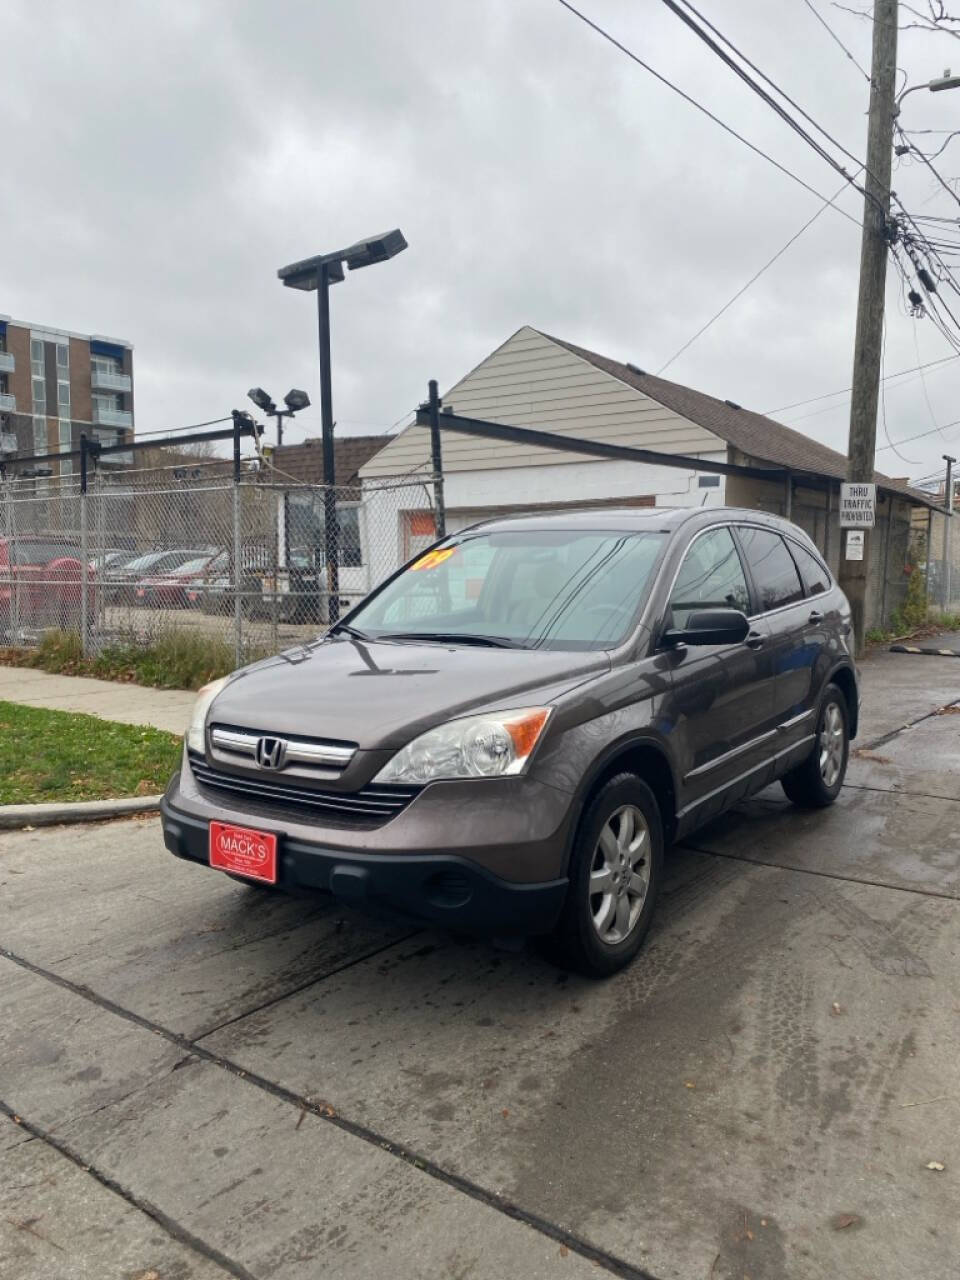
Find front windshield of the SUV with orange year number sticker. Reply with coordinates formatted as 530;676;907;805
349;529;666;649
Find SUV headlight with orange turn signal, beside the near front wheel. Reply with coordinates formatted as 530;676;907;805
374;707;550;783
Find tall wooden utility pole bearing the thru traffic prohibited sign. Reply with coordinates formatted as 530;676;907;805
840;0;897;653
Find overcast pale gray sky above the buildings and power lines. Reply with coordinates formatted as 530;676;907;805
0;0;960;477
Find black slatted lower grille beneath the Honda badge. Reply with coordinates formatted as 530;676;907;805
188;751;417;827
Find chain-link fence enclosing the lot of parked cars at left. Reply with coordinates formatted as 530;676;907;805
0;458;435;664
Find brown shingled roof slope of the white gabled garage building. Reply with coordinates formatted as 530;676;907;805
547;330;931;506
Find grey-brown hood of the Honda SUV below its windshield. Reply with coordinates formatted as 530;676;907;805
209;639;609;750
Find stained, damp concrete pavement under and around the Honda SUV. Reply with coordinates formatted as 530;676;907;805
0;654;960;1280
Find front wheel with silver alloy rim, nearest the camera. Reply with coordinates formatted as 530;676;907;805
544;773;663;978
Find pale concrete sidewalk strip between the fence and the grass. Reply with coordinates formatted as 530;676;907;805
0;667;197;733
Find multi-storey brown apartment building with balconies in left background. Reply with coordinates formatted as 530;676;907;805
0;315;133;474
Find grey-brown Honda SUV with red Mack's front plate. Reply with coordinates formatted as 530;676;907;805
163;508;859;974
